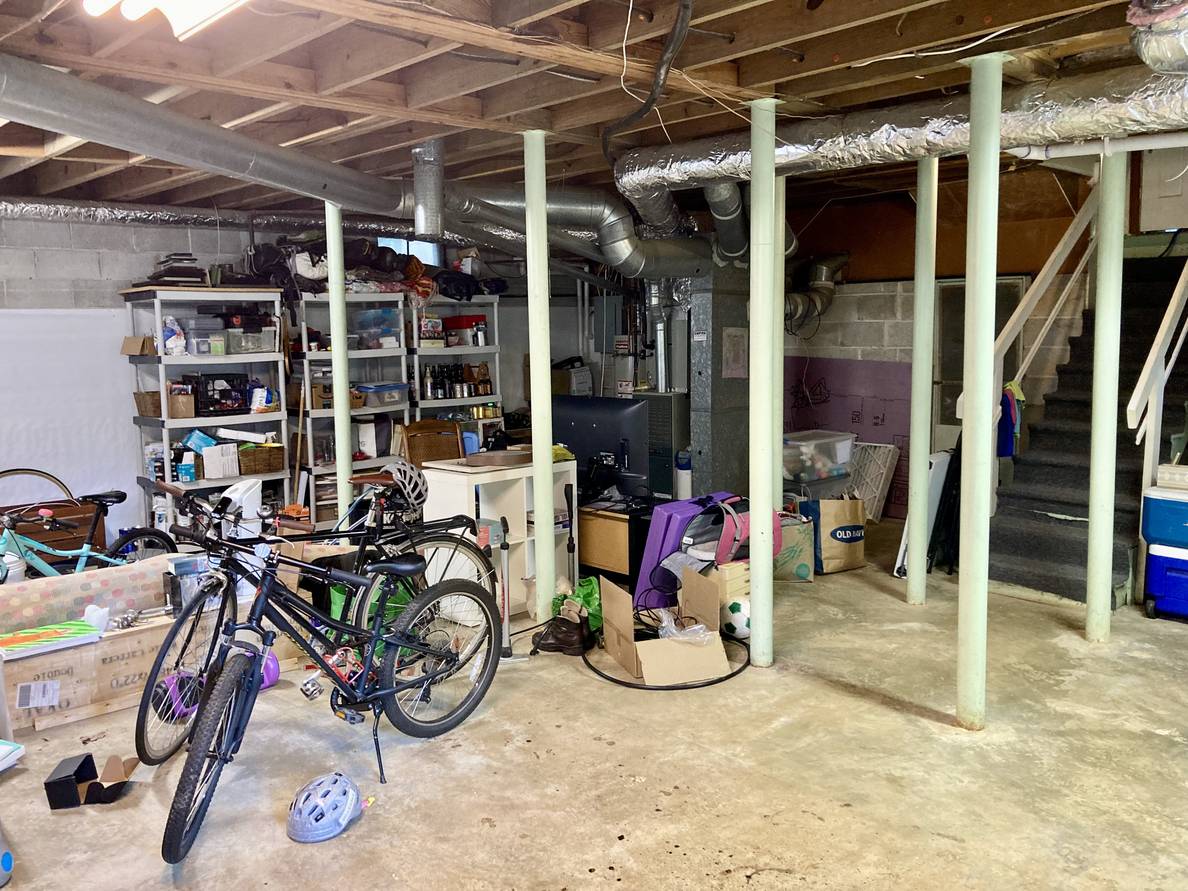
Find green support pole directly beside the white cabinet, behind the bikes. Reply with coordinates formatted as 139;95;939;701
524;129;557;621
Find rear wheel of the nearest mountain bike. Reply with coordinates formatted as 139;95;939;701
380;580;500;739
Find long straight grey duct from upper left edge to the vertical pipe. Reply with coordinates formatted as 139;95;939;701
0;53;412;219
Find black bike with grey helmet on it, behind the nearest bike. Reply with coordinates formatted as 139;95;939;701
135;482;495;764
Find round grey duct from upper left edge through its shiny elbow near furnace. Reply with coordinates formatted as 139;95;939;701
0;53;709;278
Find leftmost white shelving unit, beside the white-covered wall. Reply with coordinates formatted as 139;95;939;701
120;286;291;523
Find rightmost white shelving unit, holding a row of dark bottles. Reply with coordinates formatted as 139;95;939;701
412;295;504;438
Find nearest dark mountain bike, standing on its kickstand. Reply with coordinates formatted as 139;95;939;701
162;491;499;864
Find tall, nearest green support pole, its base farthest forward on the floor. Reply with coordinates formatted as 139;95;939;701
958;53;1005;731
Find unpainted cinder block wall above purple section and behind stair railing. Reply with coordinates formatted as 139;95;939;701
784;276;1085;404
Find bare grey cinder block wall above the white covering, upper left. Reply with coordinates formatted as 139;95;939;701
0;220;247;309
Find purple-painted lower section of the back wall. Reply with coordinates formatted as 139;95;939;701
784;356;911;519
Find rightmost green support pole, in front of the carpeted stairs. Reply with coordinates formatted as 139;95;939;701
1085;152;1126;643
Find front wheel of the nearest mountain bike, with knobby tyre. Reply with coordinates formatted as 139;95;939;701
160;652;254;864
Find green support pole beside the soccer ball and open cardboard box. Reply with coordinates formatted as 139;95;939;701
748;99;783;668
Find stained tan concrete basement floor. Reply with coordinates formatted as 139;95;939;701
0;525;1188;891
